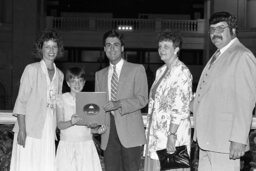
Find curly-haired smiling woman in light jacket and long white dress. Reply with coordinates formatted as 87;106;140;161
10;30;64;171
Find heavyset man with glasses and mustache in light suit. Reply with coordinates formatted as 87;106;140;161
191;12;256;171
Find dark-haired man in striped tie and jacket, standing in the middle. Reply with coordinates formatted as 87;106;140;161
95;30;148;171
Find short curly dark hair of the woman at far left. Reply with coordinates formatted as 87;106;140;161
34;29;64;58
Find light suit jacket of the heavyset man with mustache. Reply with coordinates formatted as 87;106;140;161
193;38;256;153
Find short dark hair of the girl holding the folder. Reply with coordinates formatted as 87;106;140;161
65;67;85;82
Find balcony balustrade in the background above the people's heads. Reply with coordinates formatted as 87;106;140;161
46;17;205;33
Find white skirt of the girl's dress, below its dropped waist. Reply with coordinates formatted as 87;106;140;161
56;140;102;171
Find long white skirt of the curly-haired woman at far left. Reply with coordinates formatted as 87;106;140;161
10;110;55;171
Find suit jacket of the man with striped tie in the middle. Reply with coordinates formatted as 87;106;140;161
95;61;148;150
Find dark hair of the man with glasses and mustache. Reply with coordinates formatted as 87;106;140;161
209;11;237;33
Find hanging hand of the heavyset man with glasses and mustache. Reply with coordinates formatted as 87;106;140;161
229;141;246;160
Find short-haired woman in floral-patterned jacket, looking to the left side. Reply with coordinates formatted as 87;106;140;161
145;32;192;171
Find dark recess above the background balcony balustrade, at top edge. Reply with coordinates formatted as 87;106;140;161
47;0;204;18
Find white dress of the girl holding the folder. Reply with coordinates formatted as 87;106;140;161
56;93;102;171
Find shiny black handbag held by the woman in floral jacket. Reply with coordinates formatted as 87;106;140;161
156;145;190;170
